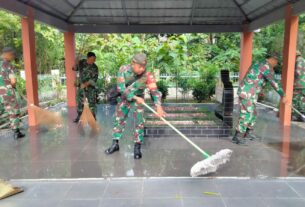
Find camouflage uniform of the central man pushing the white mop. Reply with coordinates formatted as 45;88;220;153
112;65;161;143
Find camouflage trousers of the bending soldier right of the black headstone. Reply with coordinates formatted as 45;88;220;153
236;97;257;133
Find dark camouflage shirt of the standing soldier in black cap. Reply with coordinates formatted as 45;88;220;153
74;59;98;87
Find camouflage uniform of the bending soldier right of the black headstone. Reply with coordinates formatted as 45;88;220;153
236;60;284;133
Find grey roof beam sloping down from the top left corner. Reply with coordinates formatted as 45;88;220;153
0;0;71;31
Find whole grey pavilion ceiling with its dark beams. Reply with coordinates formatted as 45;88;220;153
0;0;305;33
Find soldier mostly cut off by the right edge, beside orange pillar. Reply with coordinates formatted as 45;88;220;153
292;51;305;121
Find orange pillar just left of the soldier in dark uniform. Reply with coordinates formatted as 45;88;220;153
64;32;76;107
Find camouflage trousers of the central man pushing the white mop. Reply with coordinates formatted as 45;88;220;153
112;100;145;143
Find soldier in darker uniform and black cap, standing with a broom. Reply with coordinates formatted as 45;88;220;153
73;52;98;123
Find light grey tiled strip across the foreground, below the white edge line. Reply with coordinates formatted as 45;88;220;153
0;178;305;207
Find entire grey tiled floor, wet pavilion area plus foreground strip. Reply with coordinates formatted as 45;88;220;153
0;105;305;207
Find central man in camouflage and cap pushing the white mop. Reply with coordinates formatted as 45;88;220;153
105;53;165;159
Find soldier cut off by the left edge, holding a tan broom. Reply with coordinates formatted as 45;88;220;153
0;47;25;139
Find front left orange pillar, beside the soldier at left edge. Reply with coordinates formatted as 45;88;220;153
21;9;39;126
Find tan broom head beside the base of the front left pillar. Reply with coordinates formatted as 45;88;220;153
30;104;63;128
